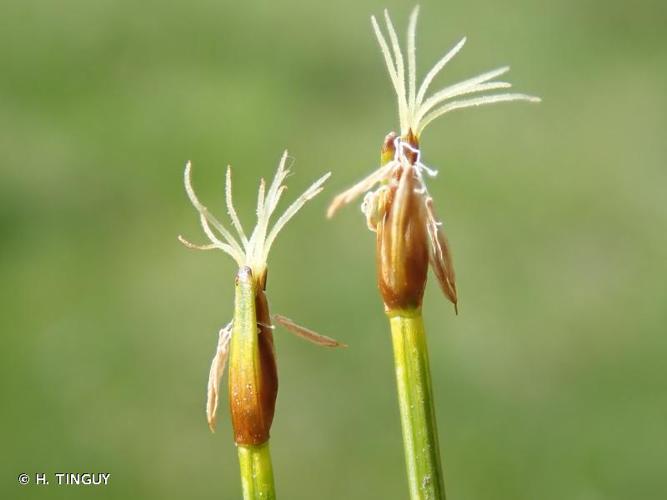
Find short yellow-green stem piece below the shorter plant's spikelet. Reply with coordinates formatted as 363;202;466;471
237;441;276;500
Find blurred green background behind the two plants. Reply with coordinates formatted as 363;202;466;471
0;0;667;500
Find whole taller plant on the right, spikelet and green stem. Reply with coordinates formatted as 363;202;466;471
328;8;539;499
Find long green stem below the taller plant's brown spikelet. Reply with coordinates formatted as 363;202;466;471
389;310;445;500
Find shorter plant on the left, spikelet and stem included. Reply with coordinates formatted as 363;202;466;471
179;151;342;500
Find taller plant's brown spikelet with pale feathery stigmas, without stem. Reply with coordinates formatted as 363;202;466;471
327;7;540;311
